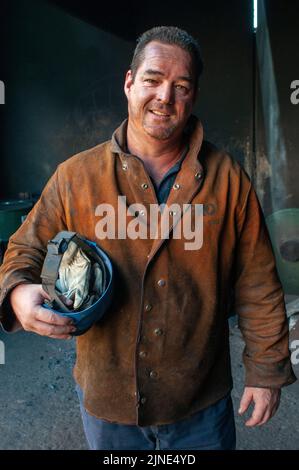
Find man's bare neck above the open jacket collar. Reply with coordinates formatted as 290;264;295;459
127;125;184;185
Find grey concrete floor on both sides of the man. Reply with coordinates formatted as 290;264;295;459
0;328;299;450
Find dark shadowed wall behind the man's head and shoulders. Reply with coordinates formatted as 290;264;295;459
0;0;299;209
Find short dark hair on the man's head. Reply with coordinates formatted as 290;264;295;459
131;26;203;89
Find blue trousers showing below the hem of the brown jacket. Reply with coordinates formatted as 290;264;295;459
76;385;236;450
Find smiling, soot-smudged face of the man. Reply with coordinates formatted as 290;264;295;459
125;41;195;140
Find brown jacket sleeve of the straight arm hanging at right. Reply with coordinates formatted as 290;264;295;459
235;184;296;388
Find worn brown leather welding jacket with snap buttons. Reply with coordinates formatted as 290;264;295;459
0;118;295;426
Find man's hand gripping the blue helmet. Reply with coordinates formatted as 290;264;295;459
10;284;76;339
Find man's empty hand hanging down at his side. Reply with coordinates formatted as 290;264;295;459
239;387;280;426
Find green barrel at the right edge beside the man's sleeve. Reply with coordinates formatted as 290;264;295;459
266;208;299;295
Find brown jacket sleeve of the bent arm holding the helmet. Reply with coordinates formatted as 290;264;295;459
0;170;66;331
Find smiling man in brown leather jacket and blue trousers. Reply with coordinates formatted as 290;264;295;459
0;27;294;449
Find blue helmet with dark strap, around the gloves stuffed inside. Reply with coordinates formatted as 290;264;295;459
41;231;113;336
